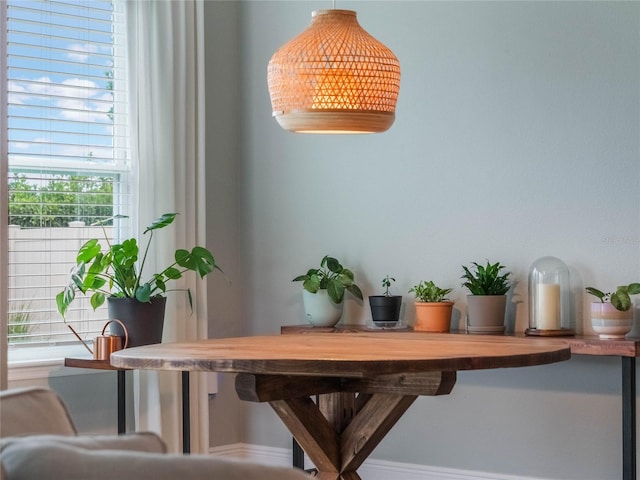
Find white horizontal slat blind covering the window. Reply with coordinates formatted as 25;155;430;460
2;0;131;347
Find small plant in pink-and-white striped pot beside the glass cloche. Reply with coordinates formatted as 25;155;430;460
585;283;640;339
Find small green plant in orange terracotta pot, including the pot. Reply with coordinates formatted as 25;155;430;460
409;280;453;332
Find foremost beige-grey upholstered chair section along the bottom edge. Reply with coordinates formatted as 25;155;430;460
2;439;308;480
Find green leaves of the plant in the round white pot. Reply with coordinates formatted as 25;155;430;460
293;255;362;303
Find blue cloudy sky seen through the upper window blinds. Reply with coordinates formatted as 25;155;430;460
7;0;122;170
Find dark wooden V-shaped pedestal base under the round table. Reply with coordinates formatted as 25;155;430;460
236;372;456;480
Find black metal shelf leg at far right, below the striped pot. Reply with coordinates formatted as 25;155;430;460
622;357;636;480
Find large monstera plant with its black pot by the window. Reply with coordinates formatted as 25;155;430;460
56;213;220;347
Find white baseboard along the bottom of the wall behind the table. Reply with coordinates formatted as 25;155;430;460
210;443;551;480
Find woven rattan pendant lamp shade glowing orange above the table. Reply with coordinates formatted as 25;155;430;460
267;10;400;133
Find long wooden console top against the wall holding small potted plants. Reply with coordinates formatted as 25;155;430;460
280;325;640;357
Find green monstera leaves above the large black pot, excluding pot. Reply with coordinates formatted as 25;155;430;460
56;213;220;317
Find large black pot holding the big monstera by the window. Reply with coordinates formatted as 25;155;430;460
107;297;167;347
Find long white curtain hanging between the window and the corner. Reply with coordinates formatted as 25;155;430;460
127;0;209;452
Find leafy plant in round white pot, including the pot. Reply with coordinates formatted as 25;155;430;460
293;255;362;327
